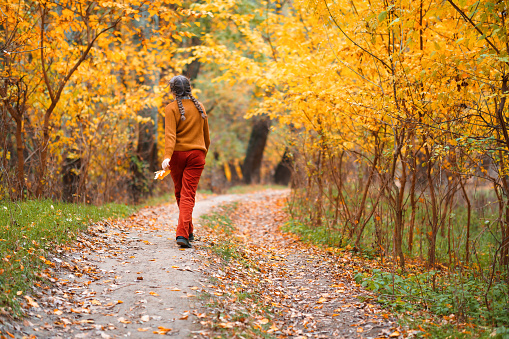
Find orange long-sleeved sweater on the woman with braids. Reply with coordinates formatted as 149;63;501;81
164;99;210;159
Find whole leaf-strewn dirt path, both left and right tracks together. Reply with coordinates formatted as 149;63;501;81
5;190;398;338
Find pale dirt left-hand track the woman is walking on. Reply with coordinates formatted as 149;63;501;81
10;195;264;338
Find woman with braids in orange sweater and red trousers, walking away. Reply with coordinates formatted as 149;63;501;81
162;75;210;248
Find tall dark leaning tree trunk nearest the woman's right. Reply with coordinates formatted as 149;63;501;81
242;116;271;184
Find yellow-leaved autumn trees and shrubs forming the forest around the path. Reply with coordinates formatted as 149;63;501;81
0;0;509;336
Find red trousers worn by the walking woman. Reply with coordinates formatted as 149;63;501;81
170;150;205;239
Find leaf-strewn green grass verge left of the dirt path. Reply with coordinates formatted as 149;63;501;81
0;200;134;316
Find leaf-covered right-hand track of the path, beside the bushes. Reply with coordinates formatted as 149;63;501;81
196;192;402;338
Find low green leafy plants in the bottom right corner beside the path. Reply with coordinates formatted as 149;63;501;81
355;269;509;326
